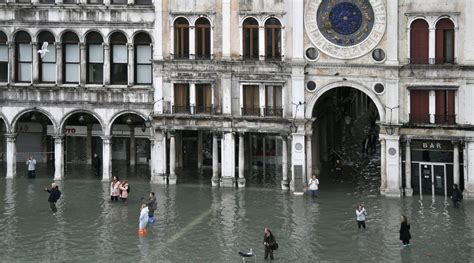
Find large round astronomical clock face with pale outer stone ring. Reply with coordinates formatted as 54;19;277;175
305;0;386;59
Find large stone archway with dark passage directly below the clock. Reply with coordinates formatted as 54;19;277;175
305;81;385;191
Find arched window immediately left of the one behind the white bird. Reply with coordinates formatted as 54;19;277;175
15;31;33;82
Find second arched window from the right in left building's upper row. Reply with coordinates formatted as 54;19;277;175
110;32;128;84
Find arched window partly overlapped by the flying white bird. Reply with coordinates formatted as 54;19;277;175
35;31;56;82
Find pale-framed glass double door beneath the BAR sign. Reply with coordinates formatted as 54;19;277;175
419;163;447;196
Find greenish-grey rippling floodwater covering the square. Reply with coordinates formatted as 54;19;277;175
0;166;474;262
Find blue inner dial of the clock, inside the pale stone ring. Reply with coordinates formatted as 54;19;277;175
317;0;374;46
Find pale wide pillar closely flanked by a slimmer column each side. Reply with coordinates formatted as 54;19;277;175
221;132;235;187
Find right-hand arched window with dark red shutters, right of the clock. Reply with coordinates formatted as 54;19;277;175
435;18;454;64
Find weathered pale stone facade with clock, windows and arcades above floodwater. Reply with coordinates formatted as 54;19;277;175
0;0;474;196
